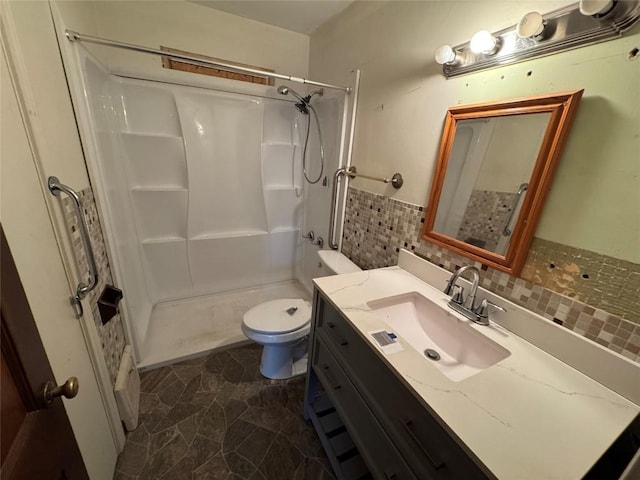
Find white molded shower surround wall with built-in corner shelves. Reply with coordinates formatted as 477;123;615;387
80;54;302;344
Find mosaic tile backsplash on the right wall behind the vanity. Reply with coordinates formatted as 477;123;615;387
342;187;640;363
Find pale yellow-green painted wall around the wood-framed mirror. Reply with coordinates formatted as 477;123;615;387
310;1;640;263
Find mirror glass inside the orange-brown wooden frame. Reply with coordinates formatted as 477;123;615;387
433;112;551;256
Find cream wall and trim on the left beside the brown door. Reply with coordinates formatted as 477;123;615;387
0;2;118;480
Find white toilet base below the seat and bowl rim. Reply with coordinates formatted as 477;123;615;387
260;337;307;380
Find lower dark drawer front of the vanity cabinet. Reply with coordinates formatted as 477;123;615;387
312;338;416;480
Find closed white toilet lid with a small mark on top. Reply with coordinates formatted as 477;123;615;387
243;298;311;333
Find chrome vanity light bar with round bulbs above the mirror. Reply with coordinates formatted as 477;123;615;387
436;0;640;77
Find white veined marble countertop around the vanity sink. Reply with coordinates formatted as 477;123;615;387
314;258;640;480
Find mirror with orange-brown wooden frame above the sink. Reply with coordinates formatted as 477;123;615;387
422;90;583;276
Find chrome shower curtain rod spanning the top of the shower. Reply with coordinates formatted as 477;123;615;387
65;29;351;93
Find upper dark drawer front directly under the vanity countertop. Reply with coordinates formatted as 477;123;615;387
317;299;493;480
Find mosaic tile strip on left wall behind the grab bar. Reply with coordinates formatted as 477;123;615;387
62;187;126;384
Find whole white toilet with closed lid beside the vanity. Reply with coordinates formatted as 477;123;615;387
242;250;360;379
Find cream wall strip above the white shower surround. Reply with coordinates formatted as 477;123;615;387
56;0;309;81
